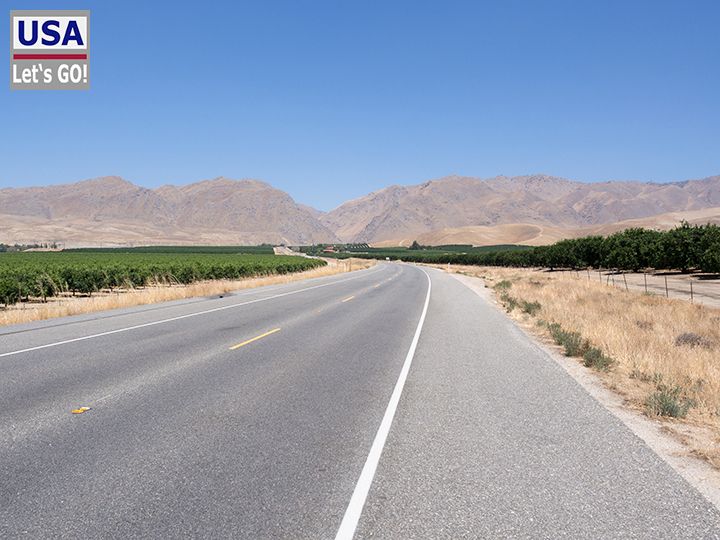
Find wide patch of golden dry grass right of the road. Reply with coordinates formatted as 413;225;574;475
442;267;720;467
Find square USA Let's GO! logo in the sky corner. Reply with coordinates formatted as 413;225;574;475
10;11;90;90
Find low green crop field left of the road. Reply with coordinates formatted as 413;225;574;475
0;248;326;306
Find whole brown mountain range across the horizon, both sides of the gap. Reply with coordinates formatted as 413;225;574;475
0;175;720;246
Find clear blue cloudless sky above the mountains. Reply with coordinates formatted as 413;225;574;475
0;0;720;210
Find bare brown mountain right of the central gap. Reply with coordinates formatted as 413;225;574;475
320;175;720;243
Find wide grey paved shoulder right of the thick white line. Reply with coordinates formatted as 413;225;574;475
356;269;720;538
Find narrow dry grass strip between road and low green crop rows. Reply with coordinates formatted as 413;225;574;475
0;259;375;326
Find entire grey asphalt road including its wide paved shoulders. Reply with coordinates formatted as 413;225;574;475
0;264;720;539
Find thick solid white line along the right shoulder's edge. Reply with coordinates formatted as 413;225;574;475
335;268;432;540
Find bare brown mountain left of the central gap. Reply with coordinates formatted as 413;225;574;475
0;176;337;245
